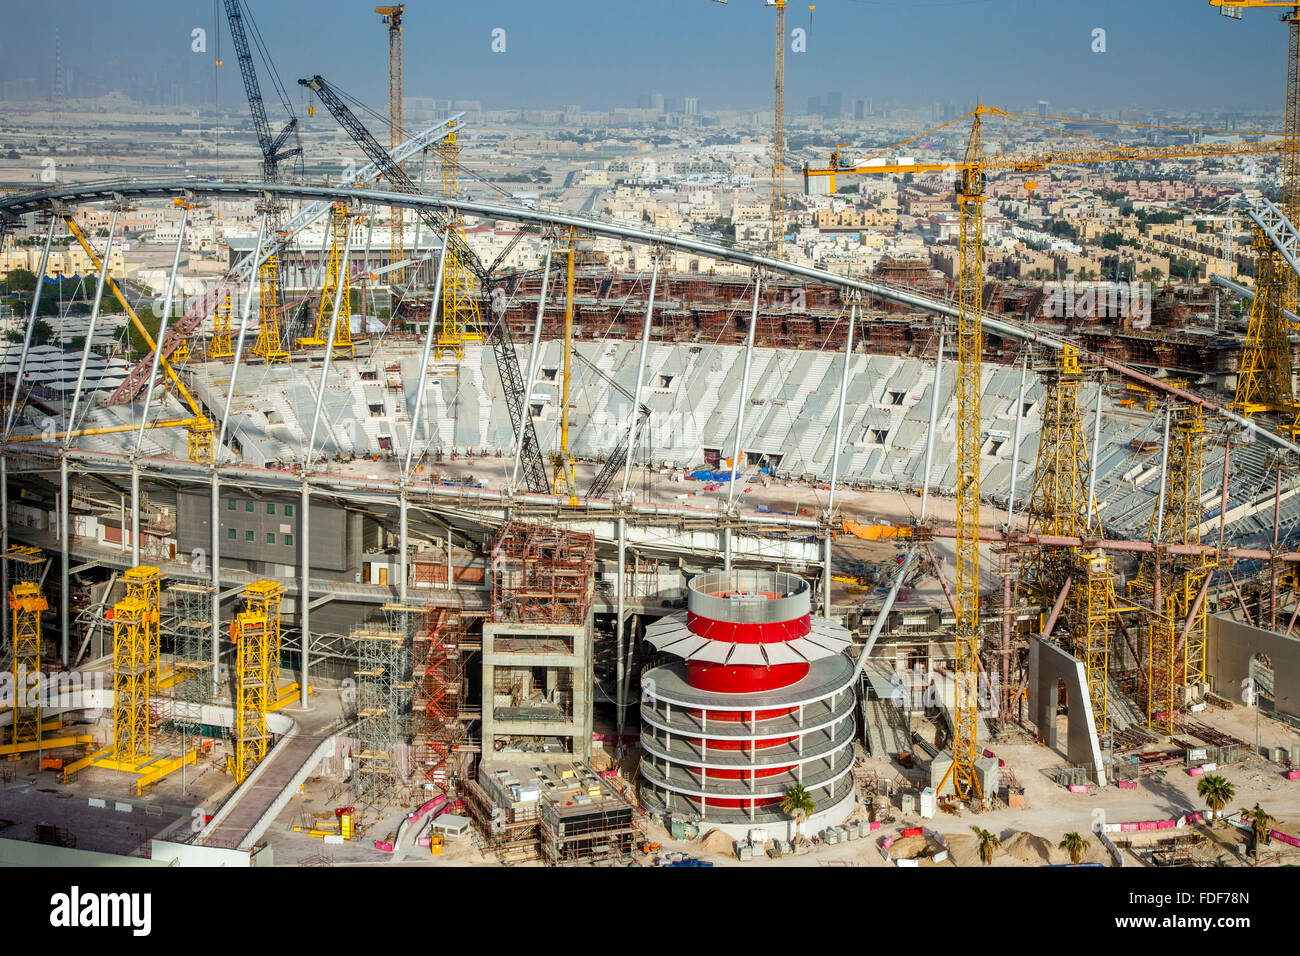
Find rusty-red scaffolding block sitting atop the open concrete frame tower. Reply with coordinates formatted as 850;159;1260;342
491;522;595;626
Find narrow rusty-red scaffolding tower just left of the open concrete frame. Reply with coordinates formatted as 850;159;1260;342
411;607;467;796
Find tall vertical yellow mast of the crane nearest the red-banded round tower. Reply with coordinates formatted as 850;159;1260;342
937;112;984;803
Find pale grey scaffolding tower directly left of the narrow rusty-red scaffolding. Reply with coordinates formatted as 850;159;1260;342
351;605;410;806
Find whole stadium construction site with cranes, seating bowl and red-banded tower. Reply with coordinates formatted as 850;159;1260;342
0;0;1300;866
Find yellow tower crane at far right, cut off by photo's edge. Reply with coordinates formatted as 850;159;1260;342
1209;0;1300;436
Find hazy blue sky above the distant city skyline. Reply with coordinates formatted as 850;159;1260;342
0;0;1286;113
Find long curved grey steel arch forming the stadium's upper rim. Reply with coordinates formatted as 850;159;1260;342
0;179;1300;455
